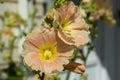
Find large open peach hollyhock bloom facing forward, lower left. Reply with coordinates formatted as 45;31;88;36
23;28;73;75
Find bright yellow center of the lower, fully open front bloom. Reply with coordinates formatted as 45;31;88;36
39;44;58;61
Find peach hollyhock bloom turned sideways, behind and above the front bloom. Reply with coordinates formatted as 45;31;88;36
54;2;89;48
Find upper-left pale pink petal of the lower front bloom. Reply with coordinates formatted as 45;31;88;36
23;30;44;55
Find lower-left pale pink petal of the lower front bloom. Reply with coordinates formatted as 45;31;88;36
24;52;43;71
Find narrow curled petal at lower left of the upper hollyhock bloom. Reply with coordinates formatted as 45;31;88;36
58;30;74;45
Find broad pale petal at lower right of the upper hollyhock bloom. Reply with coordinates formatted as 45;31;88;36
71;30;89;48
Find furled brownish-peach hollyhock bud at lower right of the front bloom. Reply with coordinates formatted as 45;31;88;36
64;62;85;74
